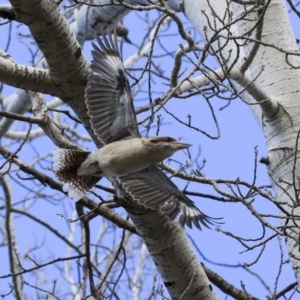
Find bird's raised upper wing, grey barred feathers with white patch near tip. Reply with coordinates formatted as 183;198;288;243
85;35;139;144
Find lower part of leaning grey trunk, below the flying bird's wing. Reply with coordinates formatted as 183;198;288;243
127;210;217;300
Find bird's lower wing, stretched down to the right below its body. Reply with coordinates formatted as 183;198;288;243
117;166;222;229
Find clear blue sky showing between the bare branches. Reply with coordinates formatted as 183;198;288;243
0;1;296;299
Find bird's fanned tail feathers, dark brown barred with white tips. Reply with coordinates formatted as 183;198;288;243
52;149;99;201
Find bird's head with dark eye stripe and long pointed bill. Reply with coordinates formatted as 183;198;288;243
145;136;192;161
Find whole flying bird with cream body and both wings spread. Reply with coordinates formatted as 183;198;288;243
52;32;221;230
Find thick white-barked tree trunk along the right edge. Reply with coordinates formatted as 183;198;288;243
183;0;300;282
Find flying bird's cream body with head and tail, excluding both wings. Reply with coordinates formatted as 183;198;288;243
53;136;192;201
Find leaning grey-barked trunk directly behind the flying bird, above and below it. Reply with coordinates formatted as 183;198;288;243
3;0;216;300
